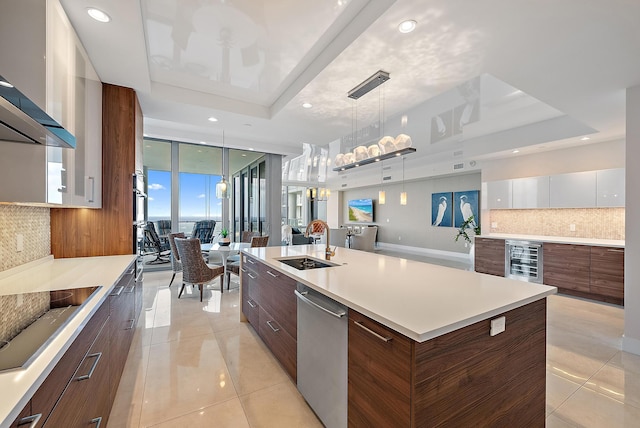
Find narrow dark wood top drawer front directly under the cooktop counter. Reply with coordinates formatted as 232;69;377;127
31;302;109;426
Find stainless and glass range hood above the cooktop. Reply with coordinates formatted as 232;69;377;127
0;72;76;149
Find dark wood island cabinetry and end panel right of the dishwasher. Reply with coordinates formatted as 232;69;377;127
348;299;546;427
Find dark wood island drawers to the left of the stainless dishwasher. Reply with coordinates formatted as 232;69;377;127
241;254;298;381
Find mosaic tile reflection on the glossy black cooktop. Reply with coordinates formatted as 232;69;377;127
0;291;50;348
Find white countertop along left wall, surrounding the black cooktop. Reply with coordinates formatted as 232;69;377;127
0;254;135;428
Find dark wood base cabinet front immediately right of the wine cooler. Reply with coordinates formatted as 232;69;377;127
543;242;591;293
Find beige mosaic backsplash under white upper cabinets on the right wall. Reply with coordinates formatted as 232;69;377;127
490;208;624;240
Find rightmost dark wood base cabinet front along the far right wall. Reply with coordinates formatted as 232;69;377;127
590;246;624;303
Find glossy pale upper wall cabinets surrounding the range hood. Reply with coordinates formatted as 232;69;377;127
0;0;102;208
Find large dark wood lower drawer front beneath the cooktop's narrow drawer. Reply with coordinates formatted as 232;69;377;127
44;320;111;428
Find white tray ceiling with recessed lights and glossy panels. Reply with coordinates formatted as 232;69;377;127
61;0;640;164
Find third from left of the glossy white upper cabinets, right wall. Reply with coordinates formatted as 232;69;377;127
549;171;597;208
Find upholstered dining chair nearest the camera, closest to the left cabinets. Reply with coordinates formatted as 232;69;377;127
174;238;224;302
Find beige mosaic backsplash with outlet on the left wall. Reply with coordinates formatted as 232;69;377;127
0;205;51;271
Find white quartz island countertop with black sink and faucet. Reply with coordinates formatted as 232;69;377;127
244;245;557;342
